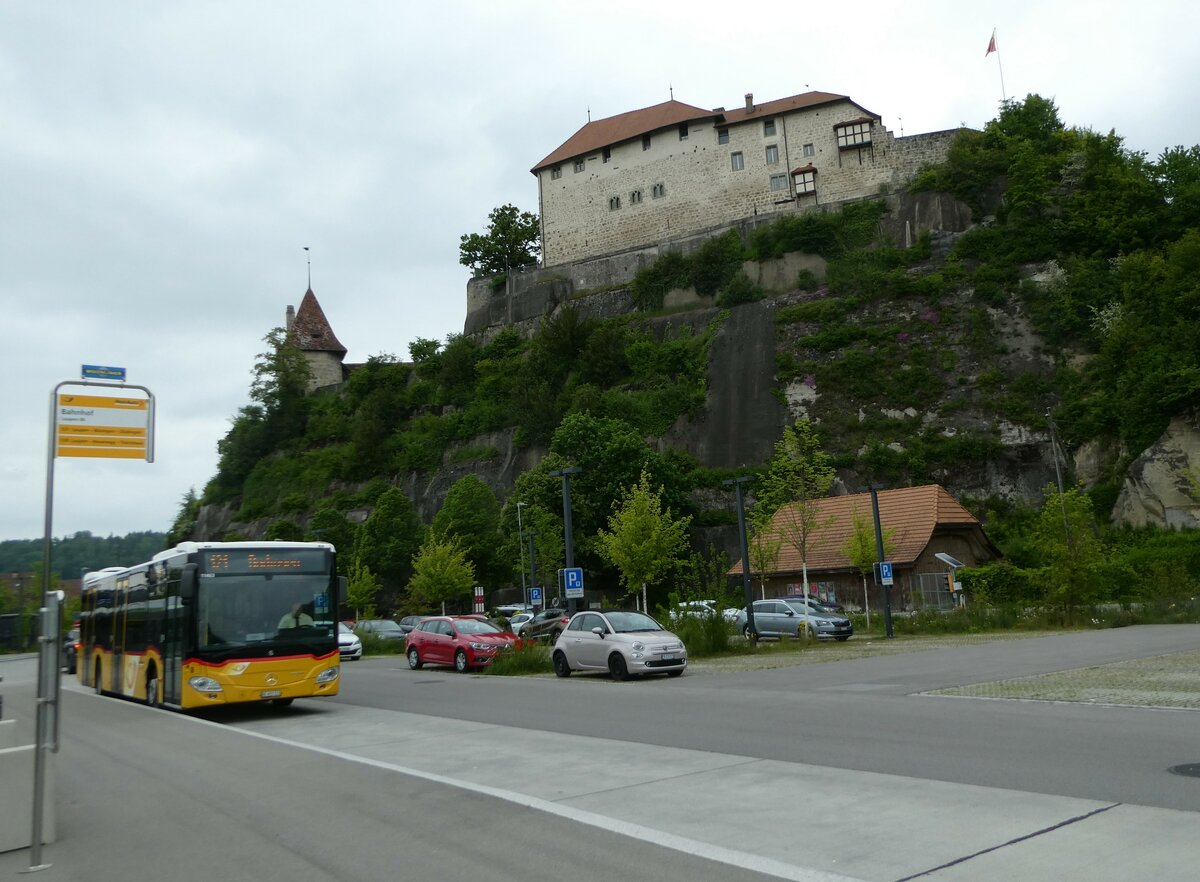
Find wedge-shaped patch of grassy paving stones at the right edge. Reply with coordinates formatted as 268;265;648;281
928;649;1200;710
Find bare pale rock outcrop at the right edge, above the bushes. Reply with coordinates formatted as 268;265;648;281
1112;414;1200;528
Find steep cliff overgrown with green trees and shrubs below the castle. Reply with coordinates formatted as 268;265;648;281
176;96;1200;592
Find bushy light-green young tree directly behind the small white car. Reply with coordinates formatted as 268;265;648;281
596;469;691;610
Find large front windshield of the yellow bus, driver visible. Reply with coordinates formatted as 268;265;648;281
197;572;335;648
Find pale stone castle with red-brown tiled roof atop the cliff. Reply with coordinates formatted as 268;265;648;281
530;91;956;266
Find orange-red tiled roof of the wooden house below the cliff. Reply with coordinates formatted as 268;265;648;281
730;484;982;574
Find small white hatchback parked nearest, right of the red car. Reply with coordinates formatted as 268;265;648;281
550;610;688;680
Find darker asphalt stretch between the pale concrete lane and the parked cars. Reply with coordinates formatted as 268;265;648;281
335;625;1200;811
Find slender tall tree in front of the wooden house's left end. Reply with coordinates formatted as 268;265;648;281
756;419;836;614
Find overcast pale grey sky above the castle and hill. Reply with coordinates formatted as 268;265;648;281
0;0;1200;540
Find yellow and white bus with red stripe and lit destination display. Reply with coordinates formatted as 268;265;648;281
78;541;342;710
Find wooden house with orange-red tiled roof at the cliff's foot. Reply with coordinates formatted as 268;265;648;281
730;484;1001;610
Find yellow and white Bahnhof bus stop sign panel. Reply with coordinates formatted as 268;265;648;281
55;394;150;460
